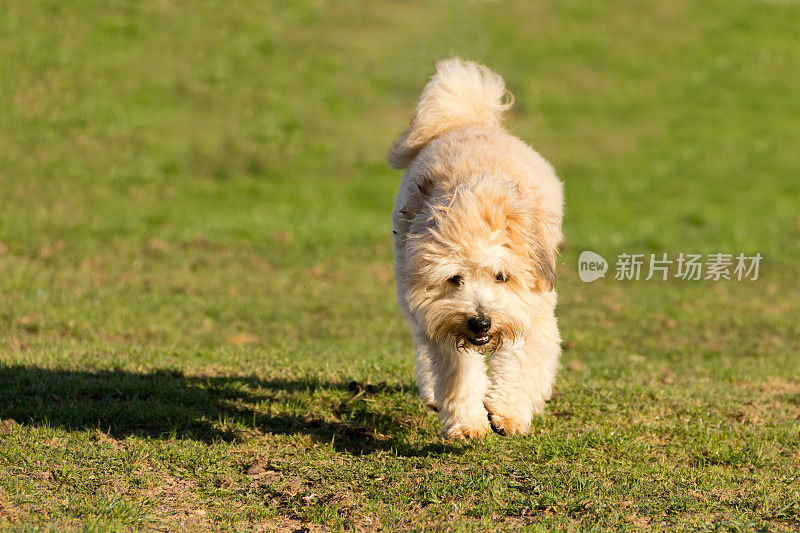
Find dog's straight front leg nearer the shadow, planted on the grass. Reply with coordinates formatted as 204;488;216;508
432;344;489;439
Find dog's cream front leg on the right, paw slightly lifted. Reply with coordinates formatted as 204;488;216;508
484;326;561;435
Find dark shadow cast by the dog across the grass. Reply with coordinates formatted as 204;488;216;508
0;365;461;456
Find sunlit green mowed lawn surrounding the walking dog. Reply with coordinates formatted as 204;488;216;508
0;0;800;531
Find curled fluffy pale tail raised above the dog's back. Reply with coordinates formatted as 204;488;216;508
386;58;514;168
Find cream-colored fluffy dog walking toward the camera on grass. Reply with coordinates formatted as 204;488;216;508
387;59;563;438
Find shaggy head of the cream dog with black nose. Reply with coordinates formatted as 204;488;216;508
407;179;556;351
